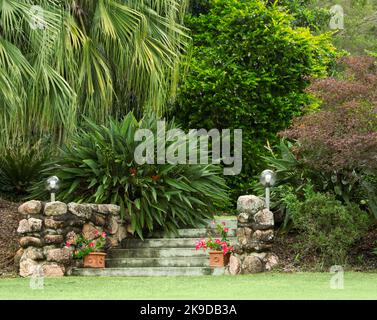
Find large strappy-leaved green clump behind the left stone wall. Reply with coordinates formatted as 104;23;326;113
33;113;228;237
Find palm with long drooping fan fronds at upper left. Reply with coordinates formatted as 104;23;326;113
0;0;188;146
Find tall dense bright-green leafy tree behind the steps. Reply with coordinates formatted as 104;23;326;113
175;0;334;205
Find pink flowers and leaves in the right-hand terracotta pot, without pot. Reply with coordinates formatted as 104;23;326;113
195;221;233;255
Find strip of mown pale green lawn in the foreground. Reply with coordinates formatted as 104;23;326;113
0;272;377;299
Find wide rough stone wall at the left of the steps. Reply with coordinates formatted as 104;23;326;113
15;200;131;277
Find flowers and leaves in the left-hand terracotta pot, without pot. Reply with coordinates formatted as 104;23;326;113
65;230;107;259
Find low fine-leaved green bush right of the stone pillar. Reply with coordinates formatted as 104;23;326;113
283;185;369;265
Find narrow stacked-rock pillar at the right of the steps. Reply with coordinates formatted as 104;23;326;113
228;195;278;275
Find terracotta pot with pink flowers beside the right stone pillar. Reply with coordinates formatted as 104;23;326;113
195;222;233;268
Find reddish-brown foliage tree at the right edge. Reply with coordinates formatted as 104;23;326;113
280;56;377;175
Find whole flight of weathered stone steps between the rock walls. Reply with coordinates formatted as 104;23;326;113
72;218;237;276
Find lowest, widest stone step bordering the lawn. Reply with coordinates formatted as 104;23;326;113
72;267;225;277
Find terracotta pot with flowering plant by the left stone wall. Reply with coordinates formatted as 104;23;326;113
66;230;107;268
